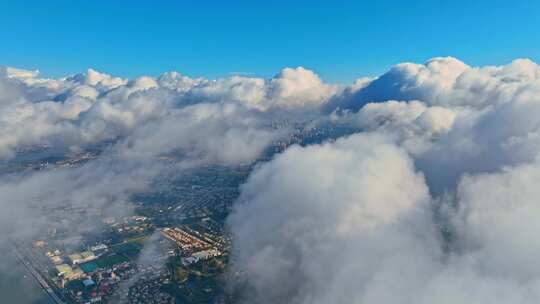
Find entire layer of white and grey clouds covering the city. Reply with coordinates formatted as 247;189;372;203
0;57;540;304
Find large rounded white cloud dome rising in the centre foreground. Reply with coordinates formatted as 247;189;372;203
229;135;437;303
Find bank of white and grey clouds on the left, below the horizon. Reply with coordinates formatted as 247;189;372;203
0;63;334;253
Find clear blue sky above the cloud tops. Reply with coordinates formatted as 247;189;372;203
0;0;540;83
